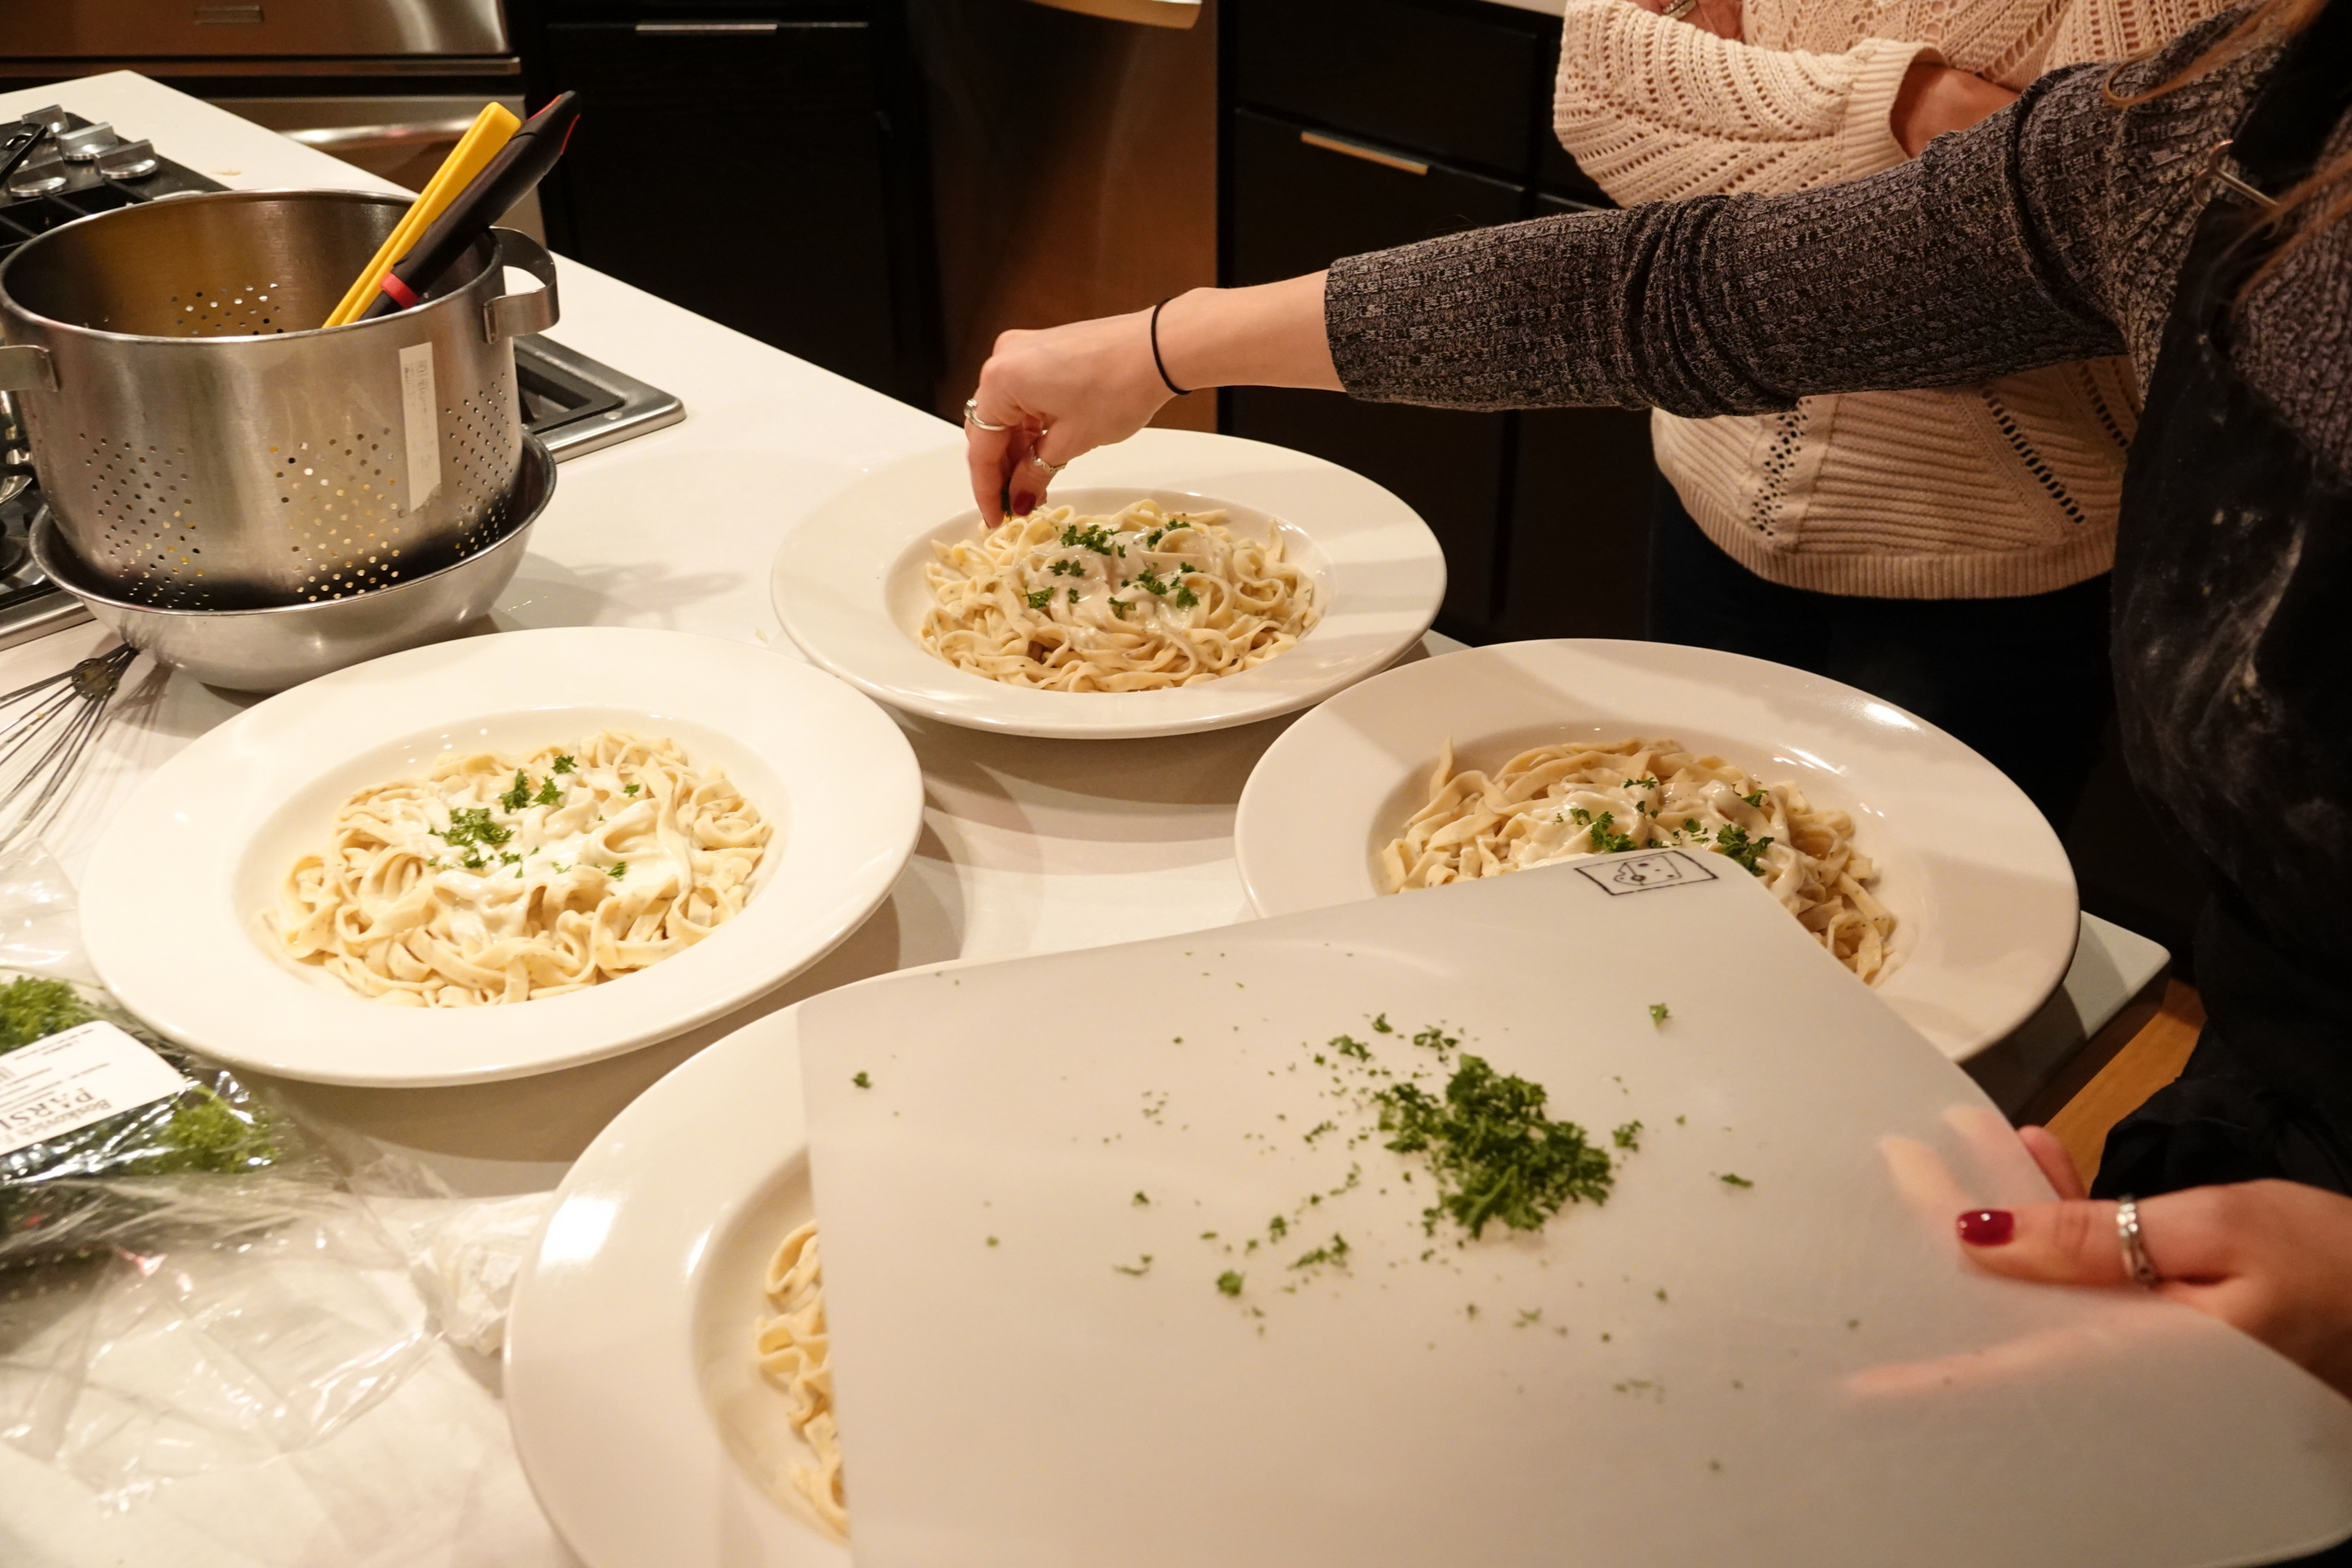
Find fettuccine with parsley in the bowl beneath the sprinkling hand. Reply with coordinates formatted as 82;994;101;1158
922;501;1319;691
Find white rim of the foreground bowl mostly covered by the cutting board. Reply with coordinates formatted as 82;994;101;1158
503;1006;849;1568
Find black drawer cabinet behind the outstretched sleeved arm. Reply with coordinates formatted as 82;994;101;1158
1218;0;1656;642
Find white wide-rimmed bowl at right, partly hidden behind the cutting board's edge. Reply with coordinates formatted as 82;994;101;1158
1232;639;2082;1060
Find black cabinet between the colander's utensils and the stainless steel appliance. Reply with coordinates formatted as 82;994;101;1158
526;0;936;402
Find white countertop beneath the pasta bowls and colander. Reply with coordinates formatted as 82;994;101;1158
0;67;2162;1568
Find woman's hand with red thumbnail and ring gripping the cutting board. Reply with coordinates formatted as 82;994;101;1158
1959;1126;2352;1396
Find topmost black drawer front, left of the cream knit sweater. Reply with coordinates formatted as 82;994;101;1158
1223;0;1557;174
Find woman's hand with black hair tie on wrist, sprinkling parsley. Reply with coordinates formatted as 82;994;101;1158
965;273;1339;526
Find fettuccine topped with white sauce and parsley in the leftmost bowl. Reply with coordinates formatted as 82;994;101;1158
270;731;769;1006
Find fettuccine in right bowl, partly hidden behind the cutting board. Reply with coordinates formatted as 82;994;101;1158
1381;740;1895;985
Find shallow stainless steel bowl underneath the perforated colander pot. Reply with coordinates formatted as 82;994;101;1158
33;434;555;691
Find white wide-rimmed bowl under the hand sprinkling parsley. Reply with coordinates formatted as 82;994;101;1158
774;430;1446;740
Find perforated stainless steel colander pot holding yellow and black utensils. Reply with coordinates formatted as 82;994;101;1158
0;190;558;609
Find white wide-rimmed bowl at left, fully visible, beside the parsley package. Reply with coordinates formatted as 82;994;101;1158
83;627;922;1086
